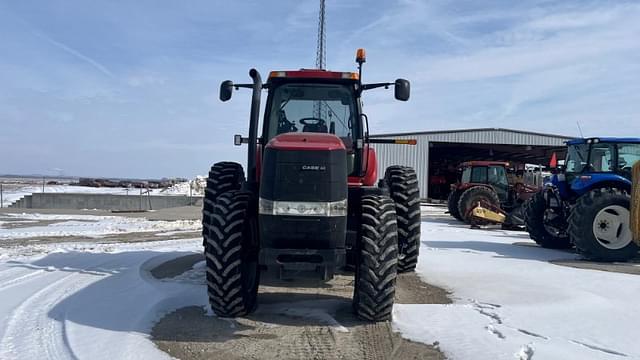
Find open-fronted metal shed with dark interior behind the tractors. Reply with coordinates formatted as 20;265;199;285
371;128;572;199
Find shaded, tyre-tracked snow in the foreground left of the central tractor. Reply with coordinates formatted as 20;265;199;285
0;239;207;360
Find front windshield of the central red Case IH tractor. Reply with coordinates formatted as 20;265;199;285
266;84;357;148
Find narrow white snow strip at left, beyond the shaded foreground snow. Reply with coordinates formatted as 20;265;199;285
0;214;202;241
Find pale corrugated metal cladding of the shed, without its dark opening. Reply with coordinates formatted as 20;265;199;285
372;129;569;199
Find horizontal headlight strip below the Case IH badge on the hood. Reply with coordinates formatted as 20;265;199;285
258;198;347;216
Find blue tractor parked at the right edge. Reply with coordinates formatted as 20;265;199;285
525;138;640;261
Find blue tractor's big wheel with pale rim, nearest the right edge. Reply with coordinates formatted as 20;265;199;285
569;188;638;261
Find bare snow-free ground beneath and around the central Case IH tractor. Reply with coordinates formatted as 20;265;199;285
151;254;451;360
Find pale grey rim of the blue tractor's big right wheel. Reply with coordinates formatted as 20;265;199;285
593;205;631;250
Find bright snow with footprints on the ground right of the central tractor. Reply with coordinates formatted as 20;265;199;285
394;207;640;360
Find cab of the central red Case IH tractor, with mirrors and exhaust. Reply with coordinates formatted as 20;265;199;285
220;49;416;186
